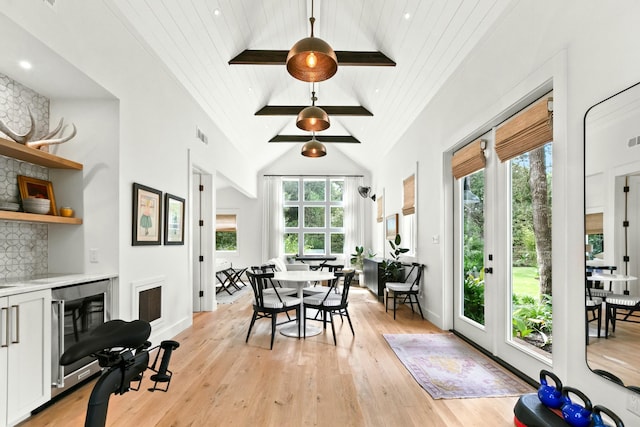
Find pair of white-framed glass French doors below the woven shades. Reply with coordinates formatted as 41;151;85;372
453;130;552;376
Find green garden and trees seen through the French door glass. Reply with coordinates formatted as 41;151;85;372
463;144;552;348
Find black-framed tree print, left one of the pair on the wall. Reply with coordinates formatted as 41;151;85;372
131;182;162;246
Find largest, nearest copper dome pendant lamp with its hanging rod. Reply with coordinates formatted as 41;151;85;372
287;0;338;82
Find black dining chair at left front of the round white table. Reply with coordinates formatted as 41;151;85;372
245;271;302;349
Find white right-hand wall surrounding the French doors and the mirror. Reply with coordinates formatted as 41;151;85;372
372;0;640;425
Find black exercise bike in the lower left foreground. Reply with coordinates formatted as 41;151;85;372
60;320;180;427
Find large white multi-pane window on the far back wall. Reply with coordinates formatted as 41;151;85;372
282;178;344;255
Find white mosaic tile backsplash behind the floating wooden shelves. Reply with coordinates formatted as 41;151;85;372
0;74;49;280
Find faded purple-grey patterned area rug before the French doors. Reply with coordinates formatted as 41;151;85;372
384;334;535;399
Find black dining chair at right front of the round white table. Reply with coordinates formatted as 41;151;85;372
302;270;355;345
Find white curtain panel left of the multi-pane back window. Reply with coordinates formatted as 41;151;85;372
262;176;284;260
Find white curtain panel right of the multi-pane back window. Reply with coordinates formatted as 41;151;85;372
344;177;368;264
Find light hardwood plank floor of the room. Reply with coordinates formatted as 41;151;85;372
21;288;534;427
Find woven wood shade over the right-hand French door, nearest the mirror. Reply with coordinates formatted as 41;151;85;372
496;96;553;162
